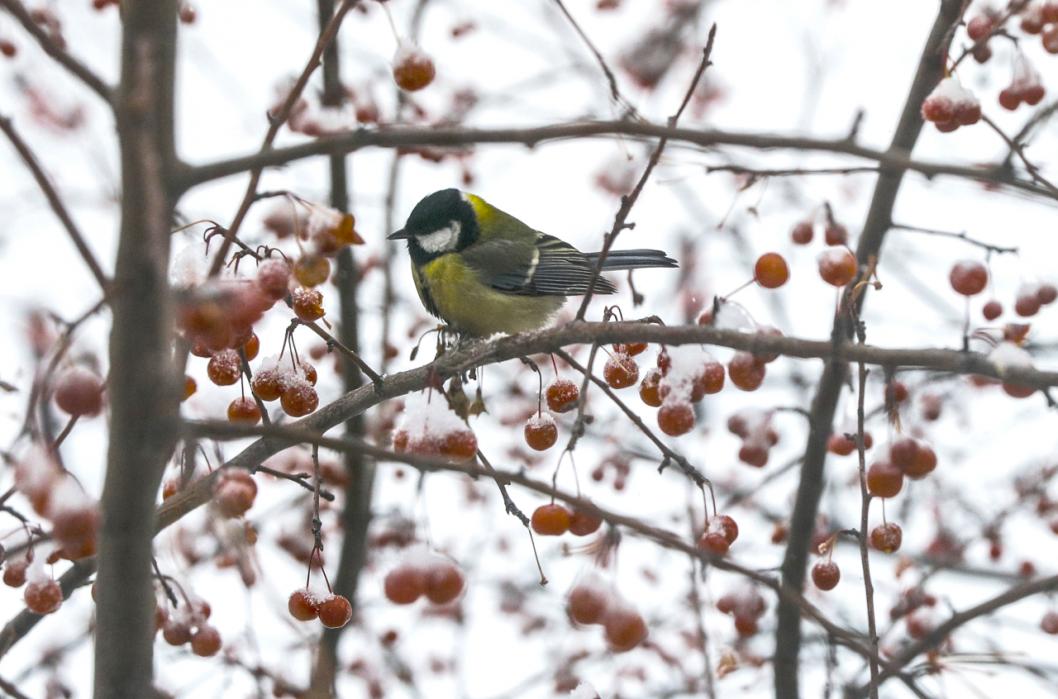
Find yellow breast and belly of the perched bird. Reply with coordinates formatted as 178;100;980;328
413;254;565;337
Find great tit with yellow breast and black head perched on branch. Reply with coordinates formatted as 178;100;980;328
389;189;677;337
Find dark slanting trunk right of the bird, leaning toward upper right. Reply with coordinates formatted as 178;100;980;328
774;0;966;697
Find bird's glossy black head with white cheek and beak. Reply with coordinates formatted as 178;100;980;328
389;189;478;264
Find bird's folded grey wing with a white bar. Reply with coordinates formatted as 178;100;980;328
463;234;616;296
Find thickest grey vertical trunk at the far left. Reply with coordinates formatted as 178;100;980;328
95;0;179;699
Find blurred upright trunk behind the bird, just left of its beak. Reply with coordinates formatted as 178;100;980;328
310;0;375;697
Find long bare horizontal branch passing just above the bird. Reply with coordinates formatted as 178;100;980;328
173;121;1054;199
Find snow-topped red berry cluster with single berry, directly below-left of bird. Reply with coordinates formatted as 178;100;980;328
249;357;320;416
